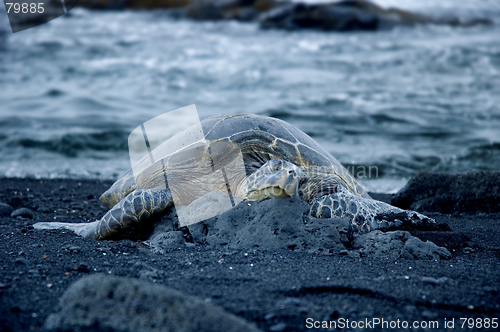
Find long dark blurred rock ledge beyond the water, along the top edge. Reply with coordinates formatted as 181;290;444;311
79;0;492;31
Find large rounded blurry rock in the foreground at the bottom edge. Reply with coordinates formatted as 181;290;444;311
44;274;262;332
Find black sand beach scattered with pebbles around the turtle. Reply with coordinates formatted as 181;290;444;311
0;172;500;331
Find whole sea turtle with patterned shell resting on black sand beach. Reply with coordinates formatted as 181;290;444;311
34;114;434;239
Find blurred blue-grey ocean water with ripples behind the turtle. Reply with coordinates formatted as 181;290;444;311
0;0;500;192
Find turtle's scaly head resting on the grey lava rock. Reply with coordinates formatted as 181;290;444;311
237;159;307;201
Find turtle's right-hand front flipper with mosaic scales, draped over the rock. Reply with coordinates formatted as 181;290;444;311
309;187;435;234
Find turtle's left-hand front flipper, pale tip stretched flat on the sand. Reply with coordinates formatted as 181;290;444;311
33;189;173;240
